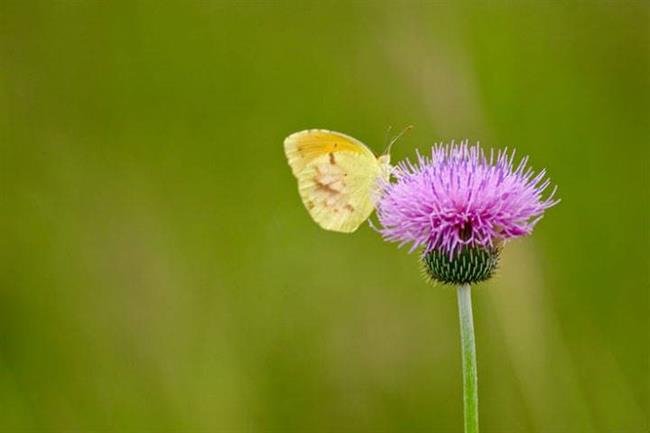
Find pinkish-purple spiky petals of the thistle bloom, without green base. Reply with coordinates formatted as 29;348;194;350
377;141;559;259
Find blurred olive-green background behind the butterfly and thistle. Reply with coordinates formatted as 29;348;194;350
0;0;650;433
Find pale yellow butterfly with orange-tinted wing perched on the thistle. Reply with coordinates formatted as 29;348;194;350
284;129;402;233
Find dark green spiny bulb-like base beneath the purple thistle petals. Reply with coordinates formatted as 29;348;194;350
422;247;501;285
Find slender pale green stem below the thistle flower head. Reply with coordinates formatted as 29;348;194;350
458;284;478;433
